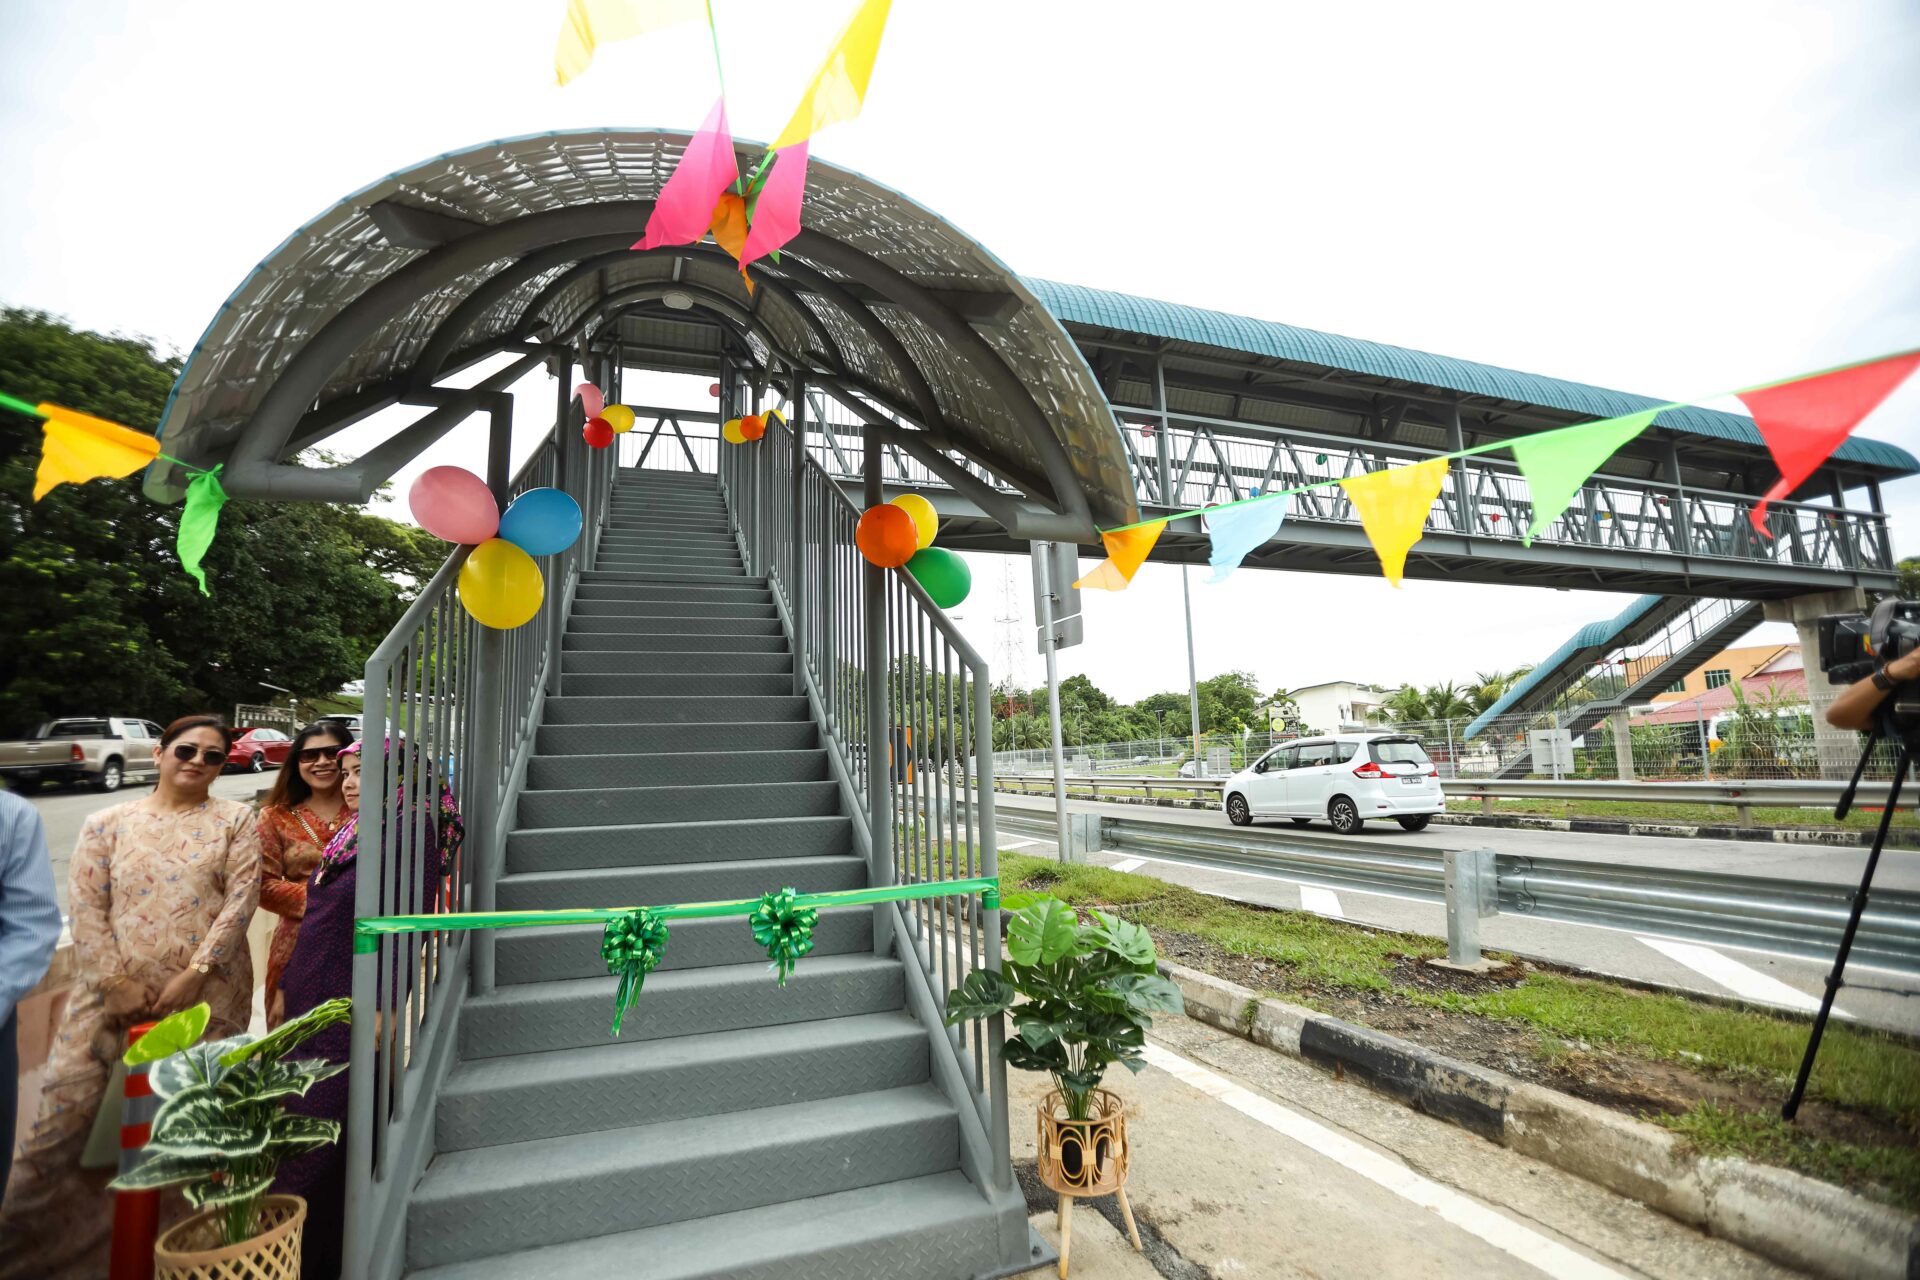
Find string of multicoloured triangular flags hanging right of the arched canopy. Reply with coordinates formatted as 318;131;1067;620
1073;347;1920;591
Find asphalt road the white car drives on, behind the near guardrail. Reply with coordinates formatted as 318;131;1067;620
996;794;1920;1034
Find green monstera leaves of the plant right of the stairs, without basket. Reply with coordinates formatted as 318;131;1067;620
947;894;1187;1121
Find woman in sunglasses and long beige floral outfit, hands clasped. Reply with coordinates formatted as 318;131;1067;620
0;716;259;1280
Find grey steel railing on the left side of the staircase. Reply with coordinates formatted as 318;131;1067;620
342;379;614;1276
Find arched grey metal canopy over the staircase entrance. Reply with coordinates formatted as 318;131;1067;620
146;130;1139;541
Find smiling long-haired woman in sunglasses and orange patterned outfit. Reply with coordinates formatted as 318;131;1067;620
259;720;353;1027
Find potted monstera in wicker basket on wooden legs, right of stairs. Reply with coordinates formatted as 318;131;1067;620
947;894;1185;1217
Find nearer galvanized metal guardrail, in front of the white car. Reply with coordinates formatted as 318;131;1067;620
1000;808;1920;975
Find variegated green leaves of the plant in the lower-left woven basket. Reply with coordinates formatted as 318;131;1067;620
111;1000;351;1245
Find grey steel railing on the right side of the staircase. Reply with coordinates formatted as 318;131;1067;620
718;403;1014;1192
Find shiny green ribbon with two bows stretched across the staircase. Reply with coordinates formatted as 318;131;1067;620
353;875;1000;1036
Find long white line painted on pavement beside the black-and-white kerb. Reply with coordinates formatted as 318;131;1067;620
1146;1040;1624;1280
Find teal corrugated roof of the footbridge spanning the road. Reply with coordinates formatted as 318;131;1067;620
1023;276;1920;474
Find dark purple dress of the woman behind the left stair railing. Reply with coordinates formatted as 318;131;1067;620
273;823;442;1280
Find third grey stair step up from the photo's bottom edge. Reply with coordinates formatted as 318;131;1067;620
434;1013;927;1151
